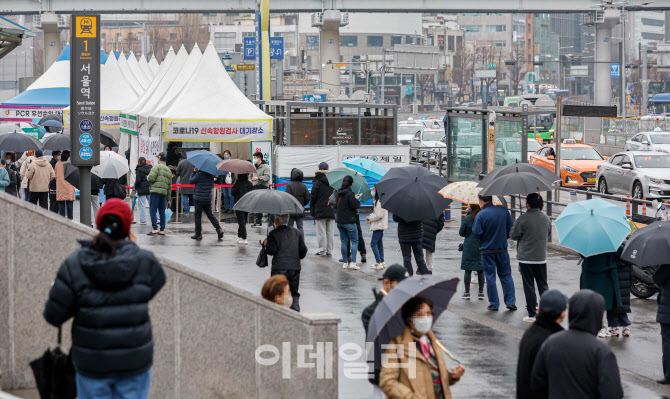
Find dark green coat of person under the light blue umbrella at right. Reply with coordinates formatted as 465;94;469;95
580;252;621;310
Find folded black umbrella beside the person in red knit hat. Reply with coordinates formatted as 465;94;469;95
30;328;77;399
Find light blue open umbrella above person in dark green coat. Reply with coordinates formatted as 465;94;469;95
556;198;631;256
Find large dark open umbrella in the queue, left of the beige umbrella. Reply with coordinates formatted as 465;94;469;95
375;166;451;222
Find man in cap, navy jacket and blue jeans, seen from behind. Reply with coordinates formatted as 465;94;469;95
472;195;517;311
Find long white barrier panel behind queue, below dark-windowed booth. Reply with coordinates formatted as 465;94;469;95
275;145;410;178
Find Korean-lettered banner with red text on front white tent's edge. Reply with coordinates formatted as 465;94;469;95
164;119;272;141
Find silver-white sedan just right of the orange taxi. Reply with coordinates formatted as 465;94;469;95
597;151;670;199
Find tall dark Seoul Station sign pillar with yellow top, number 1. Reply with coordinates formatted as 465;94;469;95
70;15;100;166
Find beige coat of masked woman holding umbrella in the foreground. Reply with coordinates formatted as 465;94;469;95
379;327;458;399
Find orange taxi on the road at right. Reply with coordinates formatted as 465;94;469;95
530;143;607;187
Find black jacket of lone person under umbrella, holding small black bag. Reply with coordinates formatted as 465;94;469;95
266;225;307;271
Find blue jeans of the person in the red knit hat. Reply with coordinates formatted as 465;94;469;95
76;369;151;399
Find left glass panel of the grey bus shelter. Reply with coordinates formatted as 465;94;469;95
448;117;483;180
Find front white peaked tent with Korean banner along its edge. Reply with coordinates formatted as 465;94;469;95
159;43;272;142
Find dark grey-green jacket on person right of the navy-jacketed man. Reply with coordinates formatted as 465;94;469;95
509;209;551;262
